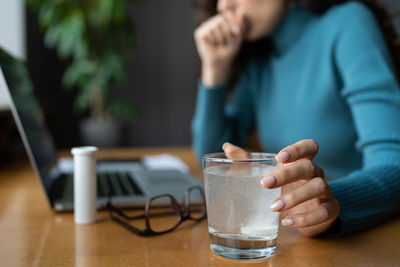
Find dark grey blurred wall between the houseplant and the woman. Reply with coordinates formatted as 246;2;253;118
117;0;198;146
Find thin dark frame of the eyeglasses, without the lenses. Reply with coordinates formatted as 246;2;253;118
106;186;207;236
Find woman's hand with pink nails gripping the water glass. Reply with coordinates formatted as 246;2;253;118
223;140;340;236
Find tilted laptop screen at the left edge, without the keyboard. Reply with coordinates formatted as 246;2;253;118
0;60;58;192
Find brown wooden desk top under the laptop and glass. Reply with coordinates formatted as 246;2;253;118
0;148;400;266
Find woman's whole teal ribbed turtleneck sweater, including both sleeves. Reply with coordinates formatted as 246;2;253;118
192;2;400;235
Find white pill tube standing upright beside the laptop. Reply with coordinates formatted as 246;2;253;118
71;146;98;224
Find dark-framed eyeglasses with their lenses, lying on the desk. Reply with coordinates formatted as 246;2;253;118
106;186;207;236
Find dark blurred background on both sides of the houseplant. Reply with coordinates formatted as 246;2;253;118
26;0;198;148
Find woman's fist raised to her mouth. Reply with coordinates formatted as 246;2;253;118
194;12;244;87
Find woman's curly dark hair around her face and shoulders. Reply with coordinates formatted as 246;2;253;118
192;0;400;89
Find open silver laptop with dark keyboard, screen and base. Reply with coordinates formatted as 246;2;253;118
0;63;203;212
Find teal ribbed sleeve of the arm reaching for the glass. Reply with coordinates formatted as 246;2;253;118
329;3;400;235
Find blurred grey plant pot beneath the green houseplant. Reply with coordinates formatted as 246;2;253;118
79;118;121;147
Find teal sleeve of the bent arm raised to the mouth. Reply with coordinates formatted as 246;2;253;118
192;68;254;158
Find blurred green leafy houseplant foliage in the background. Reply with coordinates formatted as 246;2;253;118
26;0;142;145
